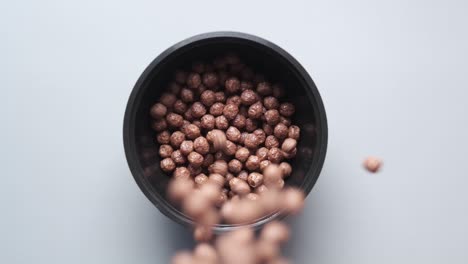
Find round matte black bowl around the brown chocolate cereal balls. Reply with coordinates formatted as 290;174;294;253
123;32;328;231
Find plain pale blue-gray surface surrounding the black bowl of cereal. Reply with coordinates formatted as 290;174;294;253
0;0;468;264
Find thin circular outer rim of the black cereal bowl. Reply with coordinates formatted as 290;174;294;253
123;31;328;232
